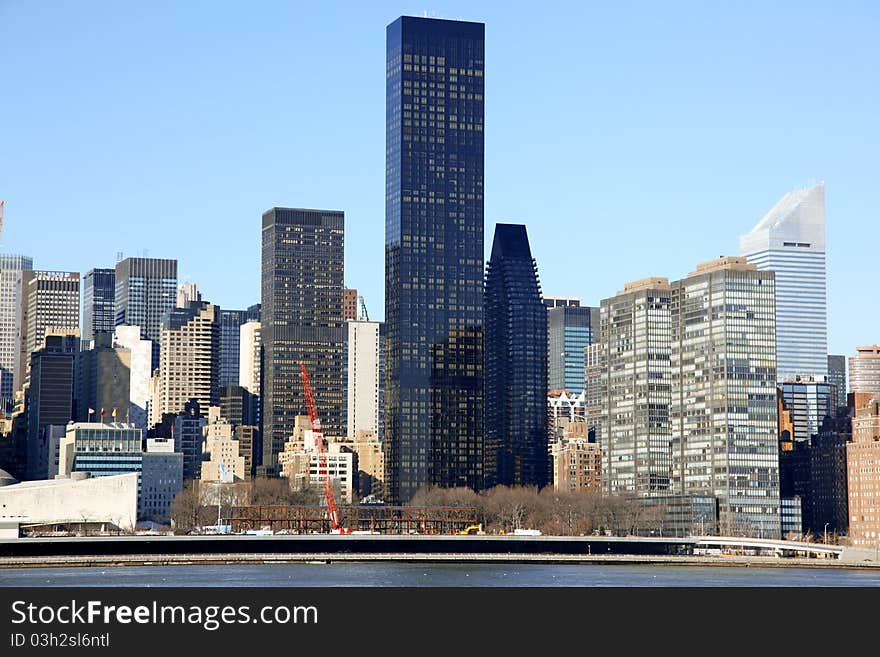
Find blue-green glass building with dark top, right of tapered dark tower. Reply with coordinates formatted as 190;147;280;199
545;300;599;395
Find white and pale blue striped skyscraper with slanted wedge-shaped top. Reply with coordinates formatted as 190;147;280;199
739;183;828;381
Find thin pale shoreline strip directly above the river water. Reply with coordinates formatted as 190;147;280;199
0;552;880;572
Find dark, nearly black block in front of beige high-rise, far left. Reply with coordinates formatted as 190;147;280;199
26;336;79;480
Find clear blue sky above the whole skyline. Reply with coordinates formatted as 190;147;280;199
0;0;880;354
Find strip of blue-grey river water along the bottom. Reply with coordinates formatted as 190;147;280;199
0;563;880;587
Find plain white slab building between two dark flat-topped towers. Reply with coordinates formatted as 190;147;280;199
345;320;382;437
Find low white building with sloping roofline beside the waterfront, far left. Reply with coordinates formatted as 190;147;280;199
0;472;138;530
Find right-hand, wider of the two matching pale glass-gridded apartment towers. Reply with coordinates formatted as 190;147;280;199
669;257;781;538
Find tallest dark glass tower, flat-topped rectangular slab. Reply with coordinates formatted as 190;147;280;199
385;16;485;502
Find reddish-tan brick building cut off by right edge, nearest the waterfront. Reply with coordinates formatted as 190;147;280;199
846;398;880;549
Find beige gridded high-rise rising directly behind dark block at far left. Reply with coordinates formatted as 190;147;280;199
20;271;79;384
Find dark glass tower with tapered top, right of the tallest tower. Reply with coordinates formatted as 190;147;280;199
484;224;550;488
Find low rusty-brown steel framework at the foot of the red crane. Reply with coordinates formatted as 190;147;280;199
223;506;479;534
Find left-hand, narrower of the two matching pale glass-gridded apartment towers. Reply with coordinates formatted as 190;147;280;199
591;278;673;496
